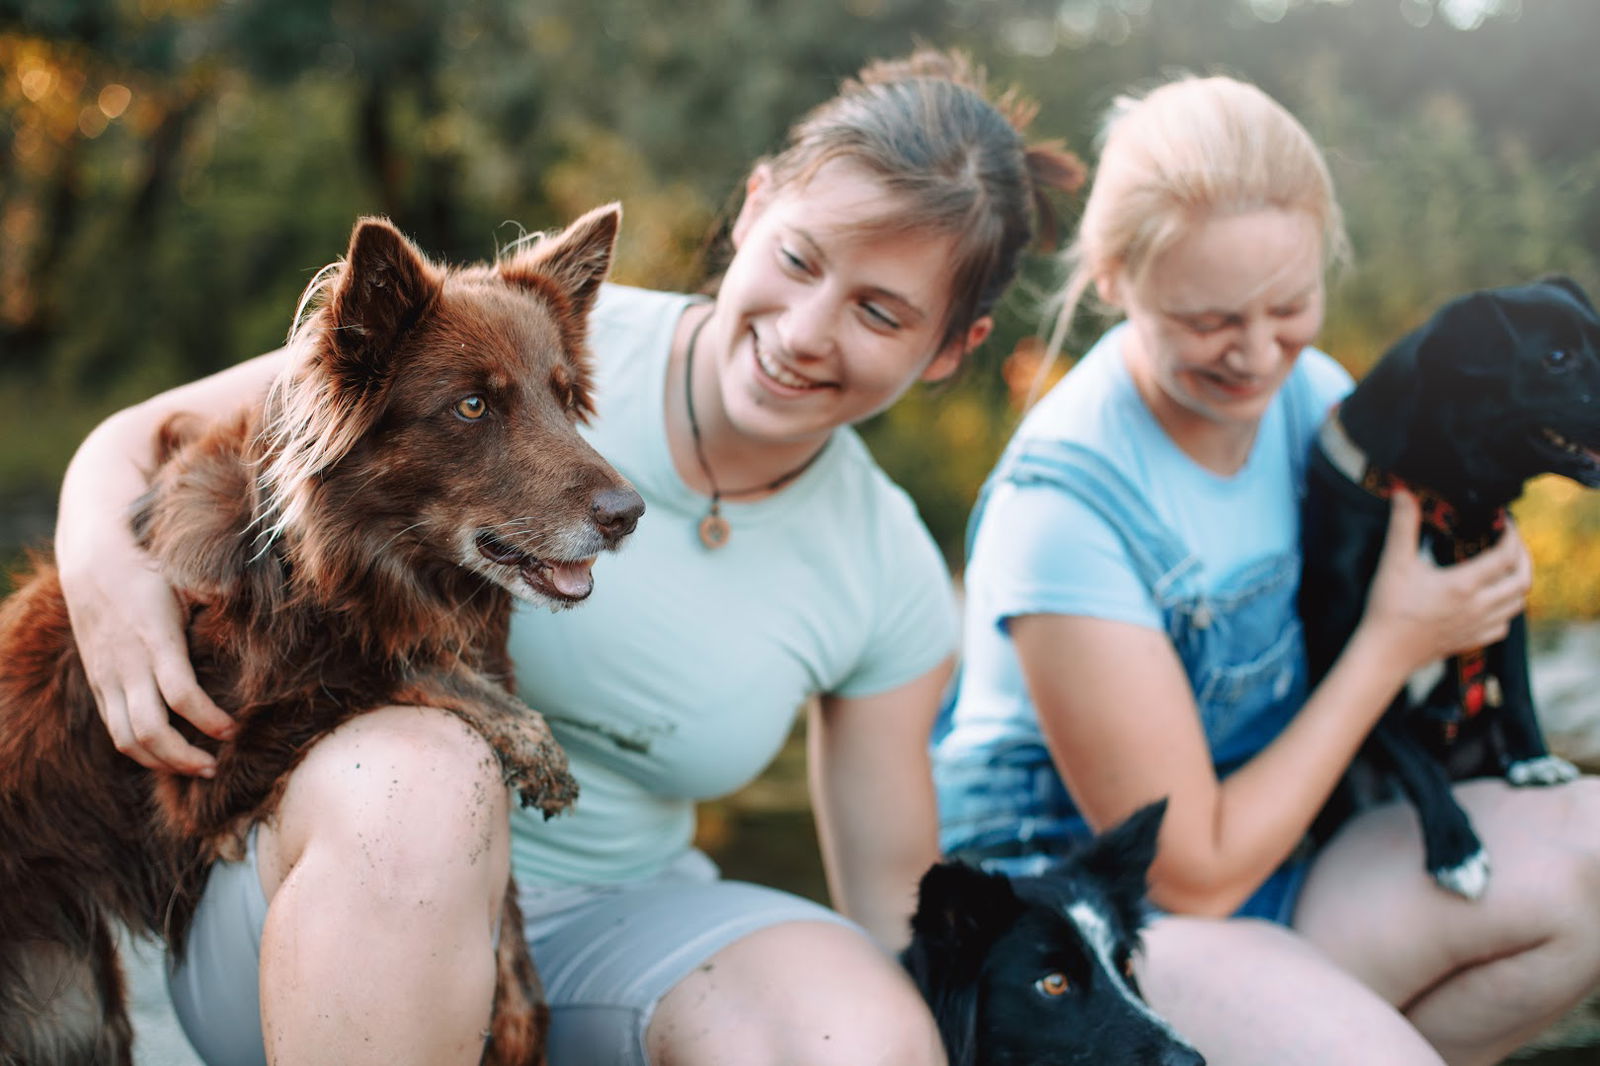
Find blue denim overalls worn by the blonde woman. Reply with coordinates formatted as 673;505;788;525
934;384;1309;924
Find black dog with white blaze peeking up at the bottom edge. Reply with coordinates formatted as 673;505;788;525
901;800;1205;1066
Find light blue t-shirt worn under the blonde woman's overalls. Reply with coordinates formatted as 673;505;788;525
939;323;1350;759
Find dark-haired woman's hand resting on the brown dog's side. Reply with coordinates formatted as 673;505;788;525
56;523;234;778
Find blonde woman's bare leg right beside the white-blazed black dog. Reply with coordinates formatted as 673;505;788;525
1139;917;1440;1066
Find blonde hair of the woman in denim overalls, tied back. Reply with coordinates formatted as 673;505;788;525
1035;77;1349;377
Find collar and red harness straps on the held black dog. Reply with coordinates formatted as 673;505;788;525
1317;407;1506;743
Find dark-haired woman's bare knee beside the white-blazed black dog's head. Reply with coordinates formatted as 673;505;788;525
648;922;944;1066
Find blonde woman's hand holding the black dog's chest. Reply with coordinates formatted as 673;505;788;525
1362;491;1533;671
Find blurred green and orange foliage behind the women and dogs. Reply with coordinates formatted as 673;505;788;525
0;0;1600;618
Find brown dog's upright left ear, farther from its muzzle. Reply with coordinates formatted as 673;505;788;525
328;218;445;382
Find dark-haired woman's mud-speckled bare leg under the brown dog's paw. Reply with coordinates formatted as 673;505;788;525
258;707;509;1066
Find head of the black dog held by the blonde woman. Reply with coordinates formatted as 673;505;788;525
1341;277;1600;507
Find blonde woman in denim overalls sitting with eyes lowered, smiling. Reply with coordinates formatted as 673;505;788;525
934;77;1600;1066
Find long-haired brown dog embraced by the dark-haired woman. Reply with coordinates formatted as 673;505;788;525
0;206;645;1066
